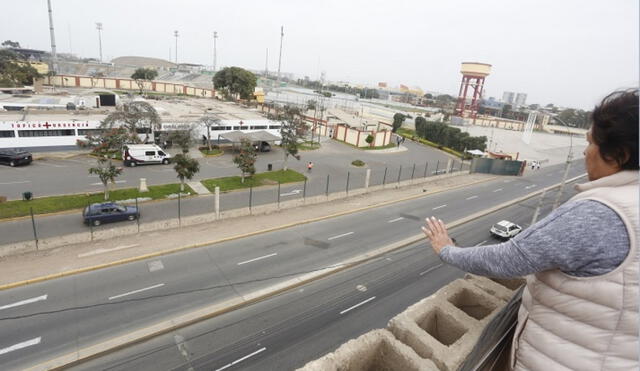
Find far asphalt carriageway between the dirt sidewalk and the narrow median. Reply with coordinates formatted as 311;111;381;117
0;161;582;369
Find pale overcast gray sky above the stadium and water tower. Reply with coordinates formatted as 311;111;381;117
0;0;639;109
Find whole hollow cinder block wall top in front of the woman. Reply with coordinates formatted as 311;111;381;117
299;274;525;371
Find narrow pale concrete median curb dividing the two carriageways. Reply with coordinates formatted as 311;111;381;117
27;174;586;370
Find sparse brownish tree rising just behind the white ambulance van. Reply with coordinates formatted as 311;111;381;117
100;102;161;142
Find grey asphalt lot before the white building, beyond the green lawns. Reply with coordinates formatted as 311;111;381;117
0;137;456;200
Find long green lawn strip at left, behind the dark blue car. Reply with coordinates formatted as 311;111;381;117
0;184;194;219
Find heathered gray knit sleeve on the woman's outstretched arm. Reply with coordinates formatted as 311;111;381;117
440;200;629;278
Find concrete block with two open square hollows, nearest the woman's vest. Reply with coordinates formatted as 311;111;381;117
388;279;506;371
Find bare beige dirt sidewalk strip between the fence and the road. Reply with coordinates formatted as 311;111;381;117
0;174;495;289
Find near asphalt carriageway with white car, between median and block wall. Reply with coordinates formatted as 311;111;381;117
74;174;575;371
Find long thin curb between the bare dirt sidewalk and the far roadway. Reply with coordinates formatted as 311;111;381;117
0;177;498;291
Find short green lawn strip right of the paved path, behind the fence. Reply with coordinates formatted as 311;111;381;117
202;169;306;192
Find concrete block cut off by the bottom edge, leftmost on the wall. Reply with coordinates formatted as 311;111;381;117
298;330;438;371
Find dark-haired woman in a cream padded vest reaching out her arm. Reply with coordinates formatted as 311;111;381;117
422;89;639;371
